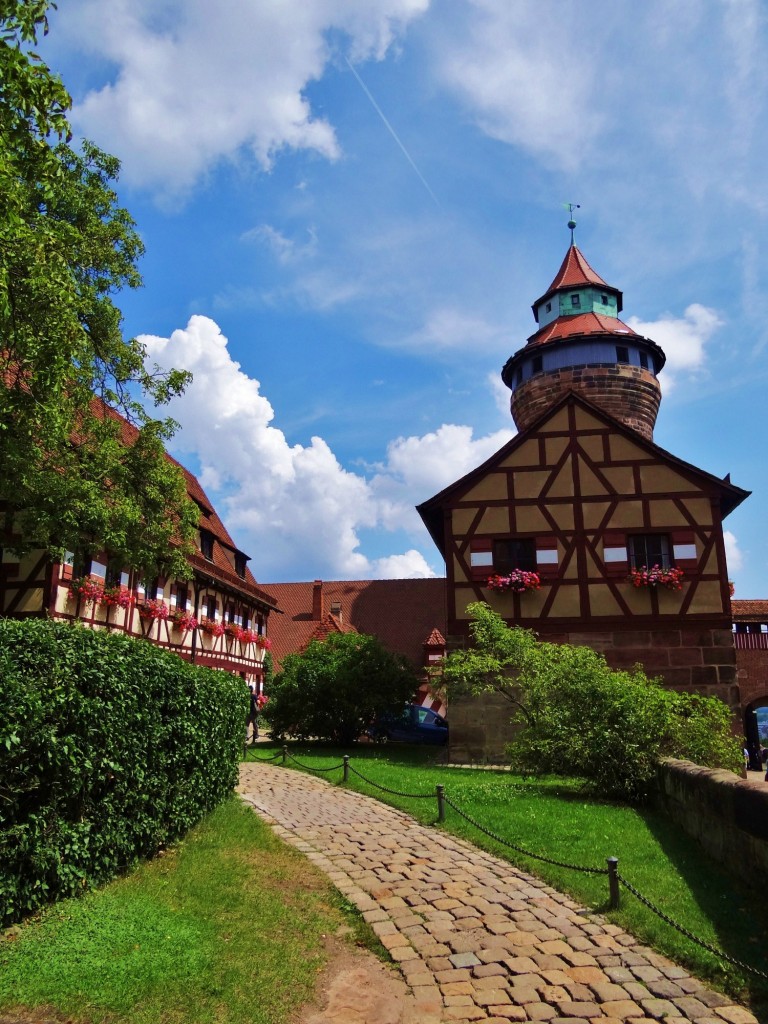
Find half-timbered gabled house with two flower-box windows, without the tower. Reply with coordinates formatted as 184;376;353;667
419;393;745;675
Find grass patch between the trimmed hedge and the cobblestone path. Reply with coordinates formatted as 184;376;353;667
0;798;372;1024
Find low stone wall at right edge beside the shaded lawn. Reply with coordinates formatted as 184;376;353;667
658;758;768;885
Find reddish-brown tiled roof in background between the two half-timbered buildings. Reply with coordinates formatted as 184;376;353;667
262;578;445;667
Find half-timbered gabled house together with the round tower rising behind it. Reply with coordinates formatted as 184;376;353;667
419;237;748;759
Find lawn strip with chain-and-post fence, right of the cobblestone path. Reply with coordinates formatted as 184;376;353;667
249;744;768;1019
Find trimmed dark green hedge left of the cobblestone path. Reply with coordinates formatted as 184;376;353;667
0;620;248;924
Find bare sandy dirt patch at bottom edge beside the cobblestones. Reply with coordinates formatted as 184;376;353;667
294;936;419;1024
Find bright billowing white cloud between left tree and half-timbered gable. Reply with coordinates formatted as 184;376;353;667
140;315;510;581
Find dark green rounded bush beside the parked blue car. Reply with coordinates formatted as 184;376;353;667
265;633;418;745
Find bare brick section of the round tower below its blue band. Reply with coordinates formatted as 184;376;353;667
511;364;662;441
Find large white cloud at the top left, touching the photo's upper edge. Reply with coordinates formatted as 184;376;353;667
61;0;429;196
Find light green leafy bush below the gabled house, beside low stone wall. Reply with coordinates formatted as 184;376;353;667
443;602;740;802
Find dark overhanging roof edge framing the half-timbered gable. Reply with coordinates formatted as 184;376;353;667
416;391;752;557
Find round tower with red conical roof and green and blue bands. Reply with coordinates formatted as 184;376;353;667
502;232;666;441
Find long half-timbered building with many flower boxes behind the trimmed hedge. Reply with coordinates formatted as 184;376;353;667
0;411;276;689
